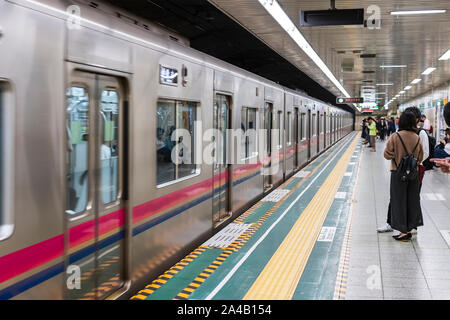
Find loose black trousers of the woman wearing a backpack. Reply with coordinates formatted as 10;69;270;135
387;171;423;233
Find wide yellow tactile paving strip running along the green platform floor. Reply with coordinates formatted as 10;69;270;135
244;137;359;300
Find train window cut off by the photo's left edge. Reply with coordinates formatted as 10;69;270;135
0;79;14;241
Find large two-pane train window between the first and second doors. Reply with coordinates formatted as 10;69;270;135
156;100;197;185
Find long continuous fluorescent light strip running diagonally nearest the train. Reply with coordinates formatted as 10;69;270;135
259;0;350;98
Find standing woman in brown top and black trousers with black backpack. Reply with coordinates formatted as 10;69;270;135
384;112;423;241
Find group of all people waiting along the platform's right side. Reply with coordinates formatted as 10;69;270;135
361;103;450;241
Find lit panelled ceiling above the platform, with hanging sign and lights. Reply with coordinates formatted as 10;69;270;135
210;0;450;112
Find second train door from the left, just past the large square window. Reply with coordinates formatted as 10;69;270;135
213;94;231;227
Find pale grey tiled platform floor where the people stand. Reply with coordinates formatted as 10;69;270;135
345;137;450;300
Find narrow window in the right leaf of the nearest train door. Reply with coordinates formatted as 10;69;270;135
100;90;119;204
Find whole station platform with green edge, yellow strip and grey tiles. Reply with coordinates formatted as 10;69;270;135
131;132;450;300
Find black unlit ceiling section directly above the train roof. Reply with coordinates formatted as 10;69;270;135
106;0;354;112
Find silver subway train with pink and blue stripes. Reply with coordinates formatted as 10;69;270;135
0;0;354;300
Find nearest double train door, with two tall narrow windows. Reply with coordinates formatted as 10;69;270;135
65;71;127;299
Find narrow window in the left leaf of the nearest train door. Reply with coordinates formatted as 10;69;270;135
66;86;89;214
